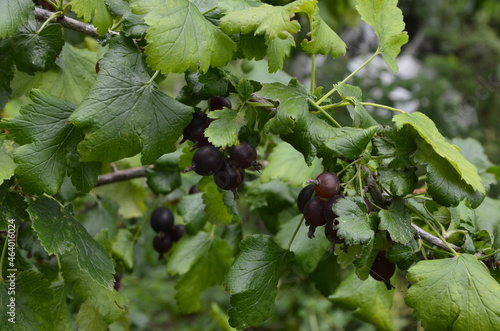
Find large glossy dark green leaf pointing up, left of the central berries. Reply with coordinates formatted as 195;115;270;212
69;38;192;164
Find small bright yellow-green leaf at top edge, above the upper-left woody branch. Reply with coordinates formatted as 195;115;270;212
71;0;113;36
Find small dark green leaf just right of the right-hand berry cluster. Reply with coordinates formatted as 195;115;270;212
377;168;418;197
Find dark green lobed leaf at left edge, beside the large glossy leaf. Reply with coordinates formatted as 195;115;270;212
0;90;101;194
